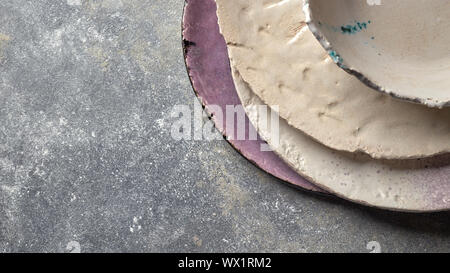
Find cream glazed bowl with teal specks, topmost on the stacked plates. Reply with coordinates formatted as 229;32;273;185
303;0;450;107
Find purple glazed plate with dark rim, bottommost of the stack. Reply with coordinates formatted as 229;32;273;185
182;0;325;193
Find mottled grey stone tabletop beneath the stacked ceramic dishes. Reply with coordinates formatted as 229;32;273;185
0;0;450;252
